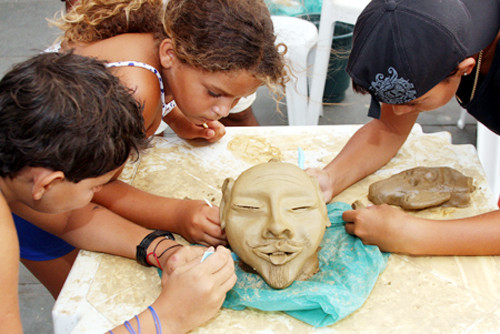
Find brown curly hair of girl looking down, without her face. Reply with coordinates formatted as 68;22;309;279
163;0;285;85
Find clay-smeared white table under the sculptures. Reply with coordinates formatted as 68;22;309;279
52;125;500;334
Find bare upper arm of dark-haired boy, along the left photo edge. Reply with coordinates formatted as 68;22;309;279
0;193;23;333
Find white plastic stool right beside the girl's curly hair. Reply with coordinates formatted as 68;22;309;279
271;16;318;125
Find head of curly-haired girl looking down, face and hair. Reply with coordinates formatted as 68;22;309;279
159;0;286;124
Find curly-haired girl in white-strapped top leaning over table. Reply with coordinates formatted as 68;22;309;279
52;0;284;142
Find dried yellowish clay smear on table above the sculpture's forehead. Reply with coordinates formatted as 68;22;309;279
227;136;283;164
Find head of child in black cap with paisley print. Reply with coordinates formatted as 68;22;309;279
346;0;500;117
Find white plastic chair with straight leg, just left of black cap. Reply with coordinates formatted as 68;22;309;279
304;0;370;125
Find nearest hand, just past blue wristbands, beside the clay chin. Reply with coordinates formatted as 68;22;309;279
153;246;236;333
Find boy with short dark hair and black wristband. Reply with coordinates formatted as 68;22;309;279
0;53;236;333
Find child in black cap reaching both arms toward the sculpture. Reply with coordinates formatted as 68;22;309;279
308;0;500;255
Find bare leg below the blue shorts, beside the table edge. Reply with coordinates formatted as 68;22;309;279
21;249;78;299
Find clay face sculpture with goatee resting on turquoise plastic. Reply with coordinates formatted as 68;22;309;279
220;161;330;289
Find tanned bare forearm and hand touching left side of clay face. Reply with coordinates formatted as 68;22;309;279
93;180;227;246
